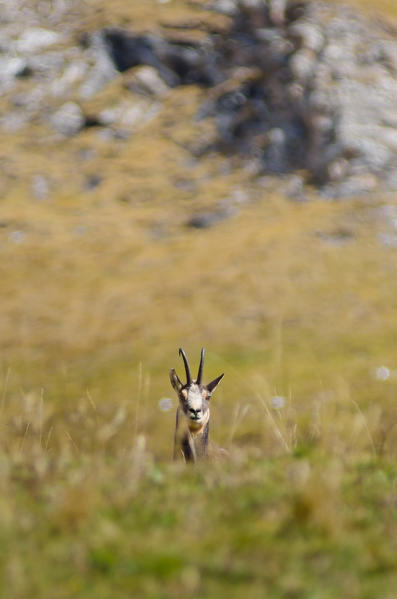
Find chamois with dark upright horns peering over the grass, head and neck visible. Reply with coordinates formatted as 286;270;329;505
170;348;223;462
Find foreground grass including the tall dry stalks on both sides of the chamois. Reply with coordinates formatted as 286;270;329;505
0;350;397;599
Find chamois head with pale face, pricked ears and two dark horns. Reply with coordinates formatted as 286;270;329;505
170;348;223;430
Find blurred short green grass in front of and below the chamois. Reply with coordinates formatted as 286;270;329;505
1;447;397;599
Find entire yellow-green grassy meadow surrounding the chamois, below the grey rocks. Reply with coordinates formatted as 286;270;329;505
0;0;397;599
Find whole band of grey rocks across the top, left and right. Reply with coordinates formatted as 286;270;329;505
0;0;397;197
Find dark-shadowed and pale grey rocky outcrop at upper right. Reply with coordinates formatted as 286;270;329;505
94;0;397;196
